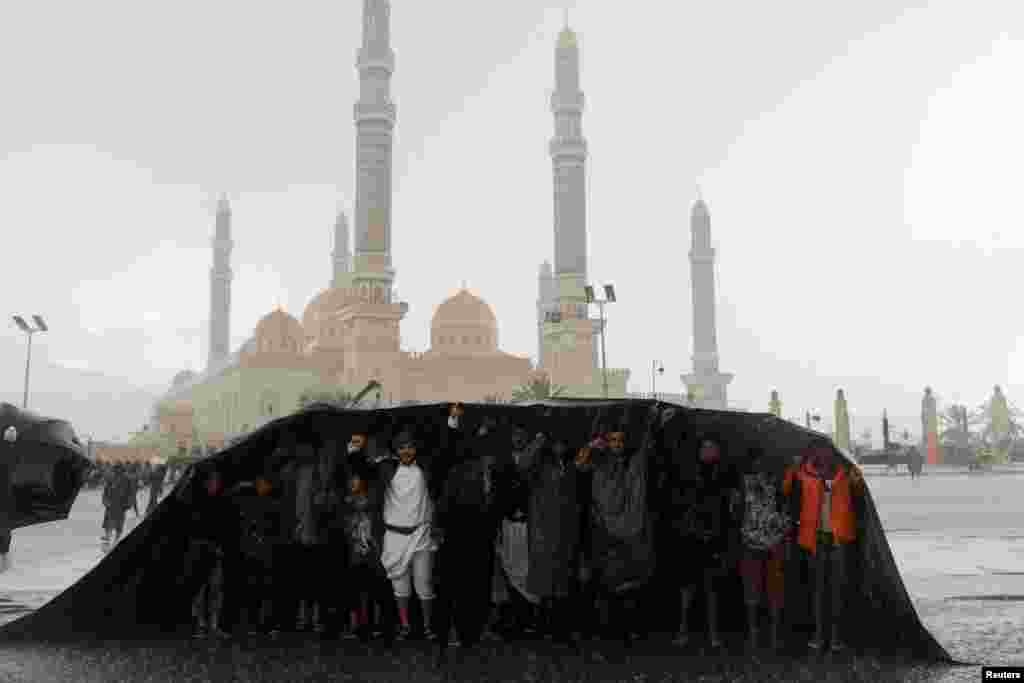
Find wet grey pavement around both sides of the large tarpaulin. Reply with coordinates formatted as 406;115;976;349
0;472;1024;681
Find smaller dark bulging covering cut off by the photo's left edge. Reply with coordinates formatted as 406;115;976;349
0;403;90;529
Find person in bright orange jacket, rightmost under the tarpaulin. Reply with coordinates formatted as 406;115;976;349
782;441;864;651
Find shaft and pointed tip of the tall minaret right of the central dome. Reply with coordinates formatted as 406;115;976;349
549;17;587;316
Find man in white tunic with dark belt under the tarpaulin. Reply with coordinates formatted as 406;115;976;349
379;430;437;639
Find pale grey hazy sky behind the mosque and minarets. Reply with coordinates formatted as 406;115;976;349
0;0;1024;436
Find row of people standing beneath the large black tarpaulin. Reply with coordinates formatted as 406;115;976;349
178;403;863;649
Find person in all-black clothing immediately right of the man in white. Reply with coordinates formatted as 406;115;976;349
437;417;509;648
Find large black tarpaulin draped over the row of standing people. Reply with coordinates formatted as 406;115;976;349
0;400;951;661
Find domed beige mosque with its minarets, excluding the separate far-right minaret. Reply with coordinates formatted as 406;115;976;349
151;0;629;454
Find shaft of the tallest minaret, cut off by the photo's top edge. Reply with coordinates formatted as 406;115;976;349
352;0;395;300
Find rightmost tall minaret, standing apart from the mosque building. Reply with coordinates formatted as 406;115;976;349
682;197;732;411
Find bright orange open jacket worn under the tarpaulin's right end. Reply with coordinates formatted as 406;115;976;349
782;466;863;554
